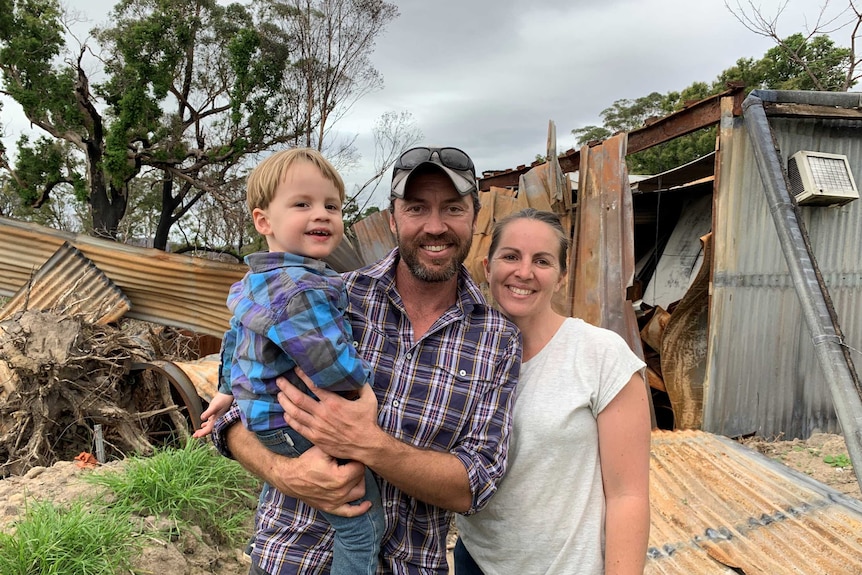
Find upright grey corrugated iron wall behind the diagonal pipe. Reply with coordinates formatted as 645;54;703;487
704;110;862;438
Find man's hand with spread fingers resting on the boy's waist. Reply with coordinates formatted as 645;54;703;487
276;368;385;461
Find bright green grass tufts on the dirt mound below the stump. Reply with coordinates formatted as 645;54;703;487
0;440;259;575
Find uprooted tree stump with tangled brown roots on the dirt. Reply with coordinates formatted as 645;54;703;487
0;311;197;477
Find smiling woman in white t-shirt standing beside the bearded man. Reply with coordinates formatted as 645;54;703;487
455;208;650;575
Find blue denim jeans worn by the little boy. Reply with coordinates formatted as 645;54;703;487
257;427;383;575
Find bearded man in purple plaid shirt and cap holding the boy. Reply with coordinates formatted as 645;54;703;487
214;147;521;575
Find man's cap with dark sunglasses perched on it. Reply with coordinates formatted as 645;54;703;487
390;147;479;199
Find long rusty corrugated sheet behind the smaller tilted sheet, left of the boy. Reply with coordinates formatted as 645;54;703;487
0;218;247;338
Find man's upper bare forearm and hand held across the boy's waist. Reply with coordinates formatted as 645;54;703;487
277;373;473;512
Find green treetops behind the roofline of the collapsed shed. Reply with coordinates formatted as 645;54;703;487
572;34;852;174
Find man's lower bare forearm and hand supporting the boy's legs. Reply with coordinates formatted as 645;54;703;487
213;404;370;517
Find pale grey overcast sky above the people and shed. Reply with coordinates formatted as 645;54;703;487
0;0;849;205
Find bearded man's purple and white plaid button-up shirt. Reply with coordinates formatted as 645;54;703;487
213;249;521;575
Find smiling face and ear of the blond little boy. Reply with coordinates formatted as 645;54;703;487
252;162;344;259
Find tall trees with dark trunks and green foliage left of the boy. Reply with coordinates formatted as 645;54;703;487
0;0;397;249
